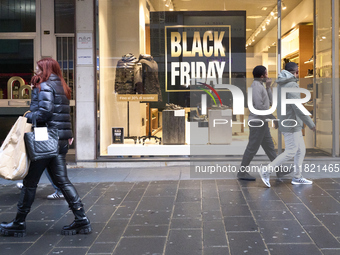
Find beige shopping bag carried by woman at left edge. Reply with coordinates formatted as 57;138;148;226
0;116;32;180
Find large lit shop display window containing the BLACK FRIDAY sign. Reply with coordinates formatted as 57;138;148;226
97;0;313;157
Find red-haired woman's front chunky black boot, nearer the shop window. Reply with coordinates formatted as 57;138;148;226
61;207;92;235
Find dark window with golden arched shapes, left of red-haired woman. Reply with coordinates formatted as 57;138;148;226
0;39;34;144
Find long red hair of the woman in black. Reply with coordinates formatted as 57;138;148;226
31;58;71;99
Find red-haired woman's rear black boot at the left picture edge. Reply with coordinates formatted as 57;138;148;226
0;212;27;237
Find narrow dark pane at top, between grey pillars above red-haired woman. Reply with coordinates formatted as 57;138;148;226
54;0;75;33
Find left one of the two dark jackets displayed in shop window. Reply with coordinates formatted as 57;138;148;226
115;53;138;94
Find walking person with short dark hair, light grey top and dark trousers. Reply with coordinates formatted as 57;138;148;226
237;66;280;181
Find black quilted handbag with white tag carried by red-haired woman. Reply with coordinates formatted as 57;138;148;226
24;114;59;161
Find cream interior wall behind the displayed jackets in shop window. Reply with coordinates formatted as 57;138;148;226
98;0;146;154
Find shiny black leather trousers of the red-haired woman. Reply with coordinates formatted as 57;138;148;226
18;141;83;214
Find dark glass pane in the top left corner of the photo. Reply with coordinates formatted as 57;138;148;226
0;0;36;32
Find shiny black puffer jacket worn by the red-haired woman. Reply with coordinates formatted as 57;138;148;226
25;74;73;140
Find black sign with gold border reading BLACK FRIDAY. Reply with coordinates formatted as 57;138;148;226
165;25;231;92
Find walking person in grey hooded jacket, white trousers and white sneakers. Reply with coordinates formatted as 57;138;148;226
260;62;315;187
